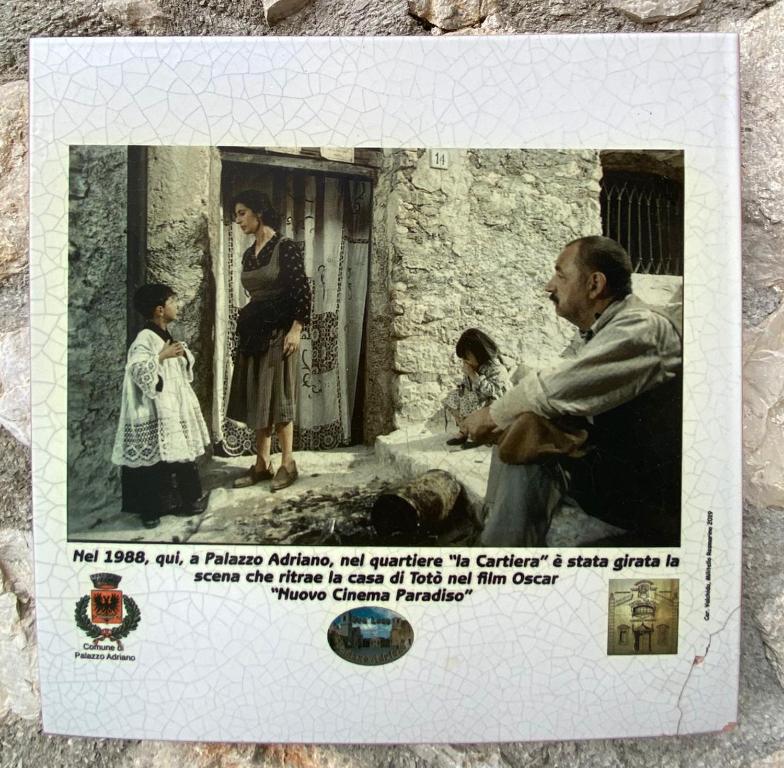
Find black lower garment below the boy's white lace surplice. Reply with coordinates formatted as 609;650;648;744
120;461;202;522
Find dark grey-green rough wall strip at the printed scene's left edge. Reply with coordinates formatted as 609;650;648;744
68;146;128;527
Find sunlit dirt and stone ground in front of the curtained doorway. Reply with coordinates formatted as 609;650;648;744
69;427;617;547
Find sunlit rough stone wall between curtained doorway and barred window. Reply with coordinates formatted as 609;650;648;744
367;149;601;437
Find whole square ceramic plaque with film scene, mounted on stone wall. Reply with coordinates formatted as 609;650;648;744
30;35;741;743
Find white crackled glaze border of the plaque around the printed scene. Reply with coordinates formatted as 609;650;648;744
23;37;738;741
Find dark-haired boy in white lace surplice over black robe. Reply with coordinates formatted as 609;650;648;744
112;283;209;528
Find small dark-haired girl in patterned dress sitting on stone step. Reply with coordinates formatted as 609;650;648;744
444;328;510;448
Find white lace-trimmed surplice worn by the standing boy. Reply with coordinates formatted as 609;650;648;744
112;329;210;467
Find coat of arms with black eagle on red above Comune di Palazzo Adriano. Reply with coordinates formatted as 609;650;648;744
74;573;141;651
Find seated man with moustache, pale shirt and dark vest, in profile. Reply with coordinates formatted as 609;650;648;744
463;236;682;546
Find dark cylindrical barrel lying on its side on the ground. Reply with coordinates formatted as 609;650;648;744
370;469;462;536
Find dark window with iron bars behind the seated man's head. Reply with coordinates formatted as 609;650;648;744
600;171;683;275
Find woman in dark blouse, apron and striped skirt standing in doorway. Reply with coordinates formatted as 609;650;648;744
226;190;310;491
